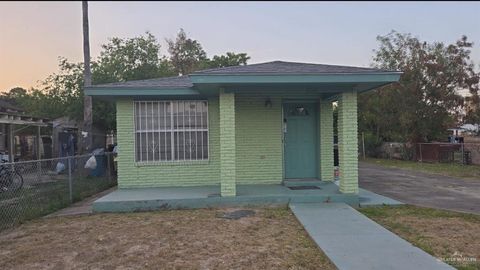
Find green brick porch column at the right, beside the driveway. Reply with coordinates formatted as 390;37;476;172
338;91;358;193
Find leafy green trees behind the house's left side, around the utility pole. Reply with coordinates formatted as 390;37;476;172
2;30;250;130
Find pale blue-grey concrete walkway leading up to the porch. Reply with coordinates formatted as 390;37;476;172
290;203;454;270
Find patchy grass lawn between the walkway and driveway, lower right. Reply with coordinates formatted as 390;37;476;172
359;206;480;269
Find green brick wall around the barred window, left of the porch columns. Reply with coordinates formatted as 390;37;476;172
117;97;220;188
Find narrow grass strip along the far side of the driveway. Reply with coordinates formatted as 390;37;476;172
360;158;480;180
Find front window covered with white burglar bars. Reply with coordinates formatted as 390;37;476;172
135;100;208;162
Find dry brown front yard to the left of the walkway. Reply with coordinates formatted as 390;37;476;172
0;208;335;269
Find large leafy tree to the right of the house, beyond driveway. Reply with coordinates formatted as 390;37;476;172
359;31;479;142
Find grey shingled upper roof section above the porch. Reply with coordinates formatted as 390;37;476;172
192;61;396;75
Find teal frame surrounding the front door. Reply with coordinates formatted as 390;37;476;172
280;99;320;181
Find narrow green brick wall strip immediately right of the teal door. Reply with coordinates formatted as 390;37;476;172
319;100;334;181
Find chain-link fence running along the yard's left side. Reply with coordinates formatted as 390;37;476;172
0;153;116;230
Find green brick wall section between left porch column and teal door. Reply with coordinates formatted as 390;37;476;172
235;93;283;184
